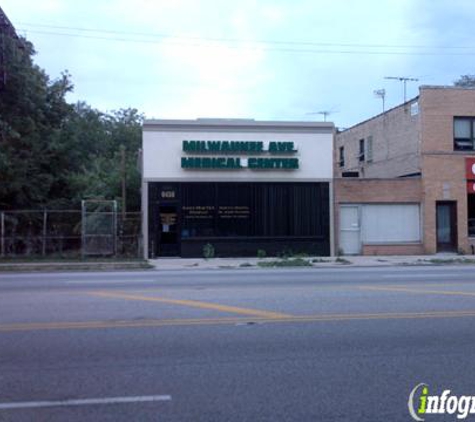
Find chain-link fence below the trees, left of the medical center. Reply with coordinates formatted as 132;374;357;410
0;210;142;258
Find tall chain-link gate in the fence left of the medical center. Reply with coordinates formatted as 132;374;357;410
81;200;117;257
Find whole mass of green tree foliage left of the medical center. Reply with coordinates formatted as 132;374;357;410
0;36;143;210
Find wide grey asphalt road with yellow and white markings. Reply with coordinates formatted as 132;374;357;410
0;266;475;422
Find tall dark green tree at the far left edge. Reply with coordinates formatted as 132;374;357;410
0;36;72;209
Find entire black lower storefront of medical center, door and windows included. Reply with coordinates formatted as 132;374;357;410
148;182;330;257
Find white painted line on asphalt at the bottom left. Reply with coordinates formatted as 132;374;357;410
0;395;172;410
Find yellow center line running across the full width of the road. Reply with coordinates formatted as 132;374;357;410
0;310;475;333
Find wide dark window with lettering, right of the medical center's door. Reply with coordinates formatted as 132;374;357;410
181;183;329;239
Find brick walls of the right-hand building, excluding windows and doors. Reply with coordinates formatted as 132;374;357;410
334;86;475;253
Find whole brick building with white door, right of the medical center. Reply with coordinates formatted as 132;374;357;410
334;86;475;254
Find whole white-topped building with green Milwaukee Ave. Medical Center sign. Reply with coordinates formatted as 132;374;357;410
142;119;334;258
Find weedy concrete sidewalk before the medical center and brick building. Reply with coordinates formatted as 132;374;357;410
149;254;475;270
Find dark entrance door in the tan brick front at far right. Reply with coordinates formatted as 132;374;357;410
436;201;457;252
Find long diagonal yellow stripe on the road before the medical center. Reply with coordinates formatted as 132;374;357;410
89;291;292;318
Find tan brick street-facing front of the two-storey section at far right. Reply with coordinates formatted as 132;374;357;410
419;87;475;253
